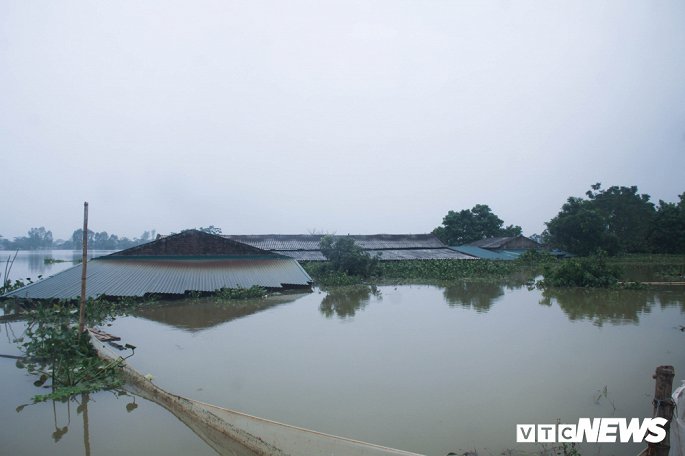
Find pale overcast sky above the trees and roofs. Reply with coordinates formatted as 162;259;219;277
0;0;685;239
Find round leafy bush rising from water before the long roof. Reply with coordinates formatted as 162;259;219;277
319;235;379;277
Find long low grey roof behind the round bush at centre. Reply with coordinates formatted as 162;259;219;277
224;234;474;261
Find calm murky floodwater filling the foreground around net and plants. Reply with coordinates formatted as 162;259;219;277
0;253;685;456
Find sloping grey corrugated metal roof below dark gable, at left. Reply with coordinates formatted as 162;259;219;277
3;257;312;299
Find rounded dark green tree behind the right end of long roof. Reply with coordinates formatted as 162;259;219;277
433;204;521;245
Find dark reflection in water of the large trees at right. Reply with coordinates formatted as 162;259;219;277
540;288;685;327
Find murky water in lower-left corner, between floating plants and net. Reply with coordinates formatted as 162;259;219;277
0;322;216;456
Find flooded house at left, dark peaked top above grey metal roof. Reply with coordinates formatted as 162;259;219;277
3;230;312;299
